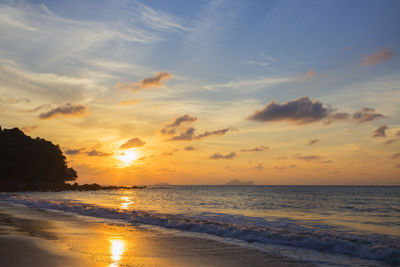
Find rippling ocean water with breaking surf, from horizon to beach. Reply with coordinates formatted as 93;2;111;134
0;186;400;266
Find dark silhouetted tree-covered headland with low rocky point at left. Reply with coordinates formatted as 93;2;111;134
0;127;142;192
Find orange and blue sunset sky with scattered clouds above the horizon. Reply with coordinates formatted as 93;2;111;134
0;0;400;185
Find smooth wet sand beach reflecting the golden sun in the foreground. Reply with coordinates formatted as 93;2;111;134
0;201;311;266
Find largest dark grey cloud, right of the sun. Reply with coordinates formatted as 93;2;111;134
247;97;331;124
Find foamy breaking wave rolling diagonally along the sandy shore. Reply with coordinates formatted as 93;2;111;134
2;195;400;264
